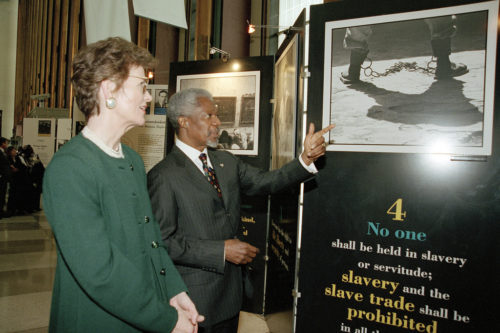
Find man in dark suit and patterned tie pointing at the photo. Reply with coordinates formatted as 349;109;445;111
148;89;333;333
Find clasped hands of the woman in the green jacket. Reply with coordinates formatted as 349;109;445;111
170;292;205;333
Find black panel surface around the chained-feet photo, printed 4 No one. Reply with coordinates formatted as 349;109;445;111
295;0;500;333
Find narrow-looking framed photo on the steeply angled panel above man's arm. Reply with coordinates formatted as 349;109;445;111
271;34;298;169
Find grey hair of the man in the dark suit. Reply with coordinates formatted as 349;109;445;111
167;88;213;132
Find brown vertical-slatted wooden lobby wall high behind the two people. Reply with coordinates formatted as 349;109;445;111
0;0;322;138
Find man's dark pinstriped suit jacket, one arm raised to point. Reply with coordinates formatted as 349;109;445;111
148;147;311;326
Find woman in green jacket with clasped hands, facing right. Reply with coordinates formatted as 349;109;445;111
43;37;203;332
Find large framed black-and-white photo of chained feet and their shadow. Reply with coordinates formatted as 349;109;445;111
323;1;498;155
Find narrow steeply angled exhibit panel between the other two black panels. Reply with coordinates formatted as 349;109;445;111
265;10;306;313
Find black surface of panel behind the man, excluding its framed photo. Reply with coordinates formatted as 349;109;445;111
171;56;274;314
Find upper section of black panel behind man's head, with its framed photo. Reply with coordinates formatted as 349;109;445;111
167;56;273;169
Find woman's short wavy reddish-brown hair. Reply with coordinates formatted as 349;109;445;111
71;37;157;119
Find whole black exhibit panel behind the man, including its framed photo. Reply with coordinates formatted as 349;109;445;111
171;56;274;314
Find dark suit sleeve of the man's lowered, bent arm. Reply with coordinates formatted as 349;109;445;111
148;168;224;273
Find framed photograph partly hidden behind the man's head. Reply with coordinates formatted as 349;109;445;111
176;71;260;155
